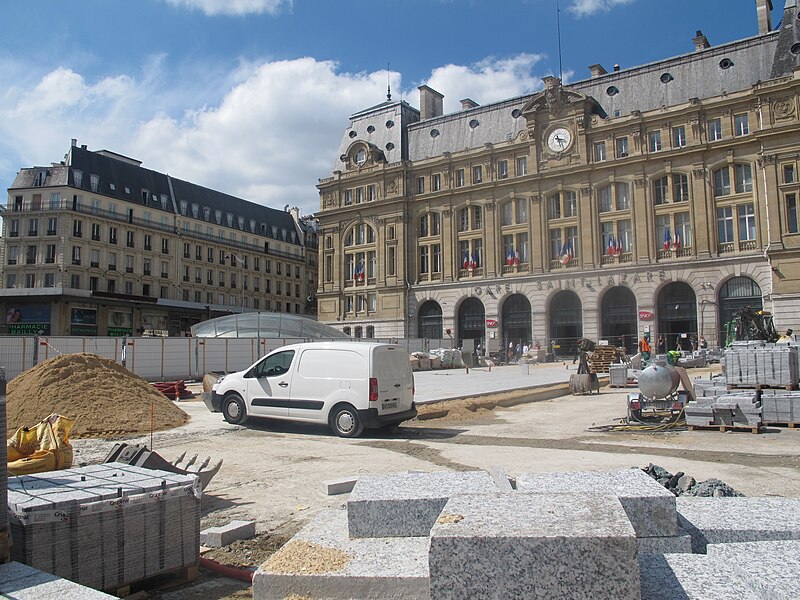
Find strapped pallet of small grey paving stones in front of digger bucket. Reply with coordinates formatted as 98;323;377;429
8;463;200;590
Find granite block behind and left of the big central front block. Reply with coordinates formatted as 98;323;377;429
347;471;498;538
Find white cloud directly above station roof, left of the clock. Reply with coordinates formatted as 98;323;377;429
427;54;543;113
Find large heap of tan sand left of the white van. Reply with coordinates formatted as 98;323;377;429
7;353;189;437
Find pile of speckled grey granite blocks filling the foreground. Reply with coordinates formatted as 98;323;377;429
253;469;800;600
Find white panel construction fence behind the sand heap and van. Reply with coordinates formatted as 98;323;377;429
0;336;439;381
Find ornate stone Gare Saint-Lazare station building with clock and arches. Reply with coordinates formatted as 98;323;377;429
317;0;800;355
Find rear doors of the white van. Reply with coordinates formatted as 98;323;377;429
370;346;414;415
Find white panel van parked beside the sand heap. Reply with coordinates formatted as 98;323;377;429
206;342;417;437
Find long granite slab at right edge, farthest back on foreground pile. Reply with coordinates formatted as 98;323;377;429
677;496;800;553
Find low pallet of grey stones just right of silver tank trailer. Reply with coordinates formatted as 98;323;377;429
684;390;762;428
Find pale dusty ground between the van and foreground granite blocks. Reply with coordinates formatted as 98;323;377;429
70;370;800;600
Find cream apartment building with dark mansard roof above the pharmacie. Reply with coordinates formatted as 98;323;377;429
0;140;317;336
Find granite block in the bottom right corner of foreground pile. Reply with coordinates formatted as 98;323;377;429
708;540;800;600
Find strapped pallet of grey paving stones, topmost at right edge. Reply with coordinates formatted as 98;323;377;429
723;342;798;388
